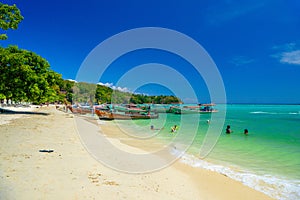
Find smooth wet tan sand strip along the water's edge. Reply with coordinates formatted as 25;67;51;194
95;116;272;199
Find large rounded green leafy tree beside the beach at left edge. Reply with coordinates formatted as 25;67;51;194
0;46;63;103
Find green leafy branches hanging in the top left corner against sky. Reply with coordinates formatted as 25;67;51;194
0;3;24;40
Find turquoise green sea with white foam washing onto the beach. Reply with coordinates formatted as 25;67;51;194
116;104;300;200
